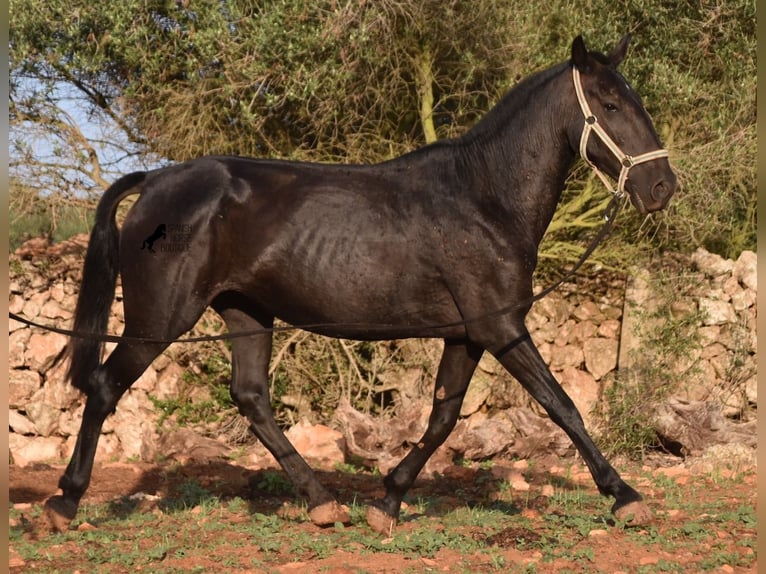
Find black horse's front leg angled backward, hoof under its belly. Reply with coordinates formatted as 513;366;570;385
367;341;483;534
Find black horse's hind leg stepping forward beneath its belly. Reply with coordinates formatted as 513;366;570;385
214;303;350;526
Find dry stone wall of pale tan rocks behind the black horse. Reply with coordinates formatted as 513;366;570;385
8;235;757;465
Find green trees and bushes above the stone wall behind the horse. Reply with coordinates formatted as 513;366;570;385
10;0;756;258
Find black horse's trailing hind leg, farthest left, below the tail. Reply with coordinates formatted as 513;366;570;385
44;343;167;532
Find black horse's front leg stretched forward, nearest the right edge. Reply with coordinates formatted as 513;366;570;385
493;329;652;525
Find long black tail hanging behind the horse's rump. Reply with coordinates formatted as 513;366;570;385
62;171;146;394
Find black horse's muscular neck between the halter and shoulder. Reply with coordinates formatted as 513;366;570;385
464;64;580;245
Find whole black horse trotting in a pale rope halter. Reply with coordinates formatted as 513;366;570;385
46;36;676;532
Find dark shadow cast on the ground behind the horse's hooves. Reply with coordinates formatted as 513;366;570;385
9;459;579;535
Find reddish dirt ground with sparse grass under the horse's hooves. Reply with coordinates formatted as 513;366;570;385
9;457;757;573
